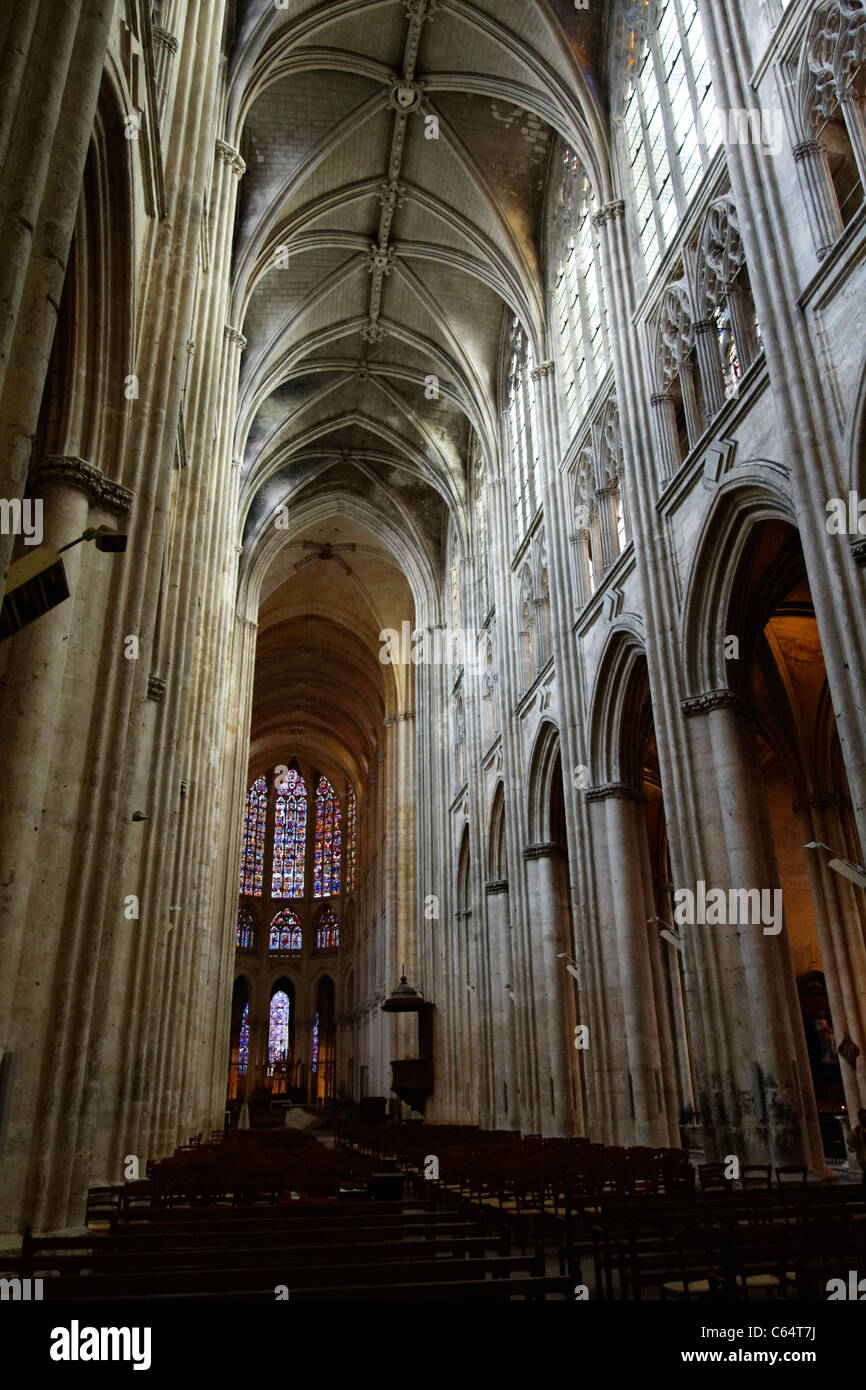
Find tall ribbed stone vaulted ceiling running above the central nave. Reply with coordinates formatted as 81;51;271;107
227;0;605;800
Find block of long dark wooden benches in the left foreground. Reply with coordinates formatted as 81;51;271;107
10;1201;573;1301
